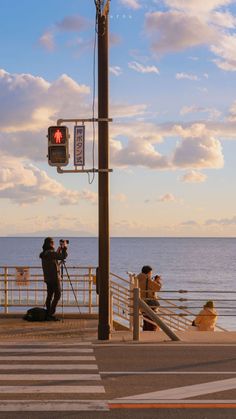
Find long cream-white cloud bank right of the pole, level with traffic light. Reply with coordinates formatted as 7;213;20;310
110;122;227;170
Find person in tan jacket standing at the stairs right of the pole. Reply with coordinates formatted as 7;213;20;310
137;265;162;331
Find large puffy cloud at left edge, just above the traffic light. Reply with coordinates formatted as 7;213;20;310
0;70;90;132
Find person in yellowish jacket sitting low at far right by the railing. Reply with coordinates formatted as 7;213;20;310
192;300;218;332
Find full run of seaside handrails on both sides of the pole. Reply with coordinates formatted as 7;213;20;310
0;265;232;331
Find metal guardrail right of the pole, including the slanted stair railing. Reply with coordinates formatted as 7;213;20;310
111;274;230;331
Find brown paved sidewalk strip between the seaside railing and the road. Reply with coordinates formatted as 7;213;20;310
0;318;236;345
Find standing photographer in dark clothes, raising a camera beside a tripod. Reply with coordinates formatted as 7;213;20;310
39;237;67;320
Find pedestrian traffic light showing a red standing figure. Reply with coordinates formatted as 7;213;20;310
48;125;69;166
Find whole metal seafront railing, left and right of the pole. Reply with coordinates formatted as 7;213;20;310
0;266;232;331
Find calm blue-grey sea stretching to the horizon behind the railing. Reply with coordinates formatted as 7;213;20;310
0;237;236;329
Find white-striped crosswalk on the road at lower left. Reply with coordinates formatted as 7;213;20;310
0;341;109;412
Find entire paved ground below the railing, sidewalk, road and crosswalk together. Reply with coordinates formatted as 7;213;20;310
0;319;236;419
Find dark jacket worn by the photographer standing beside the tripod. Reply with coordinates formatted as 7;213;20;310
39;248;67;285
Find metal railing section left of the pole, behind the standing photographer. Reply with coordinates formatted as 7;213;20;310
0;266;98;314
